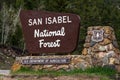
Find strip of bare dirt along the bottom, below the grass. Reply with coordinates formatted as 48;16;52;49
0;75;116;80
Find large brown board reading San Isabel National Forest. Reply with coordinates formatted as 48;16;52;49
20;10;80;54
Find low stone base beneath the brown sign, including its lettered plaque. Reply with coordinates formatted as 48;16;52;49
12;55;92;71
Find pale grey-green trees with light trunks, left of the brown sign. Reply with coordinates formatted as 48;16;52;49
0;3;21;44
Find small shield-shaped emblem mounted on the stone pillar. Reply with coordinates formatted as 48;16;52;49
92;30;104;42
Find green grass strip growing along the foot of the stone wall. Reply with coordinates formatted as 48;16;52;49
12;67;116;76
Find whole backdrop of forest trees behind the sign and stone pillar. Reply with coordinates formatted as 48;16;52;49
0;0;120;54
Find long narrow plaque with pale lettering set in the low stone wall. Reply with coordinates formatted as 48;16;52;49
22;58;70;65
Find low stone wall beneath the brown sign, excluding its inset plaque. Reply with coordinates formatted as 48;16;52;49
12;55;92;71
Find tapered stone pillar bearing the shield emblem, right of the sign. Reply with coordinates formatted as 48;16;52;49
82;26;120;66
